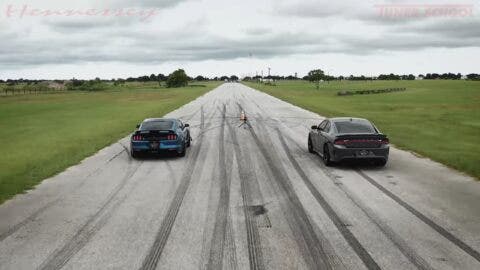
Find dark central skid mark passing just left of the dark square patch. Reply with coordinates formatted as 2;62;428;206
227;121;265;270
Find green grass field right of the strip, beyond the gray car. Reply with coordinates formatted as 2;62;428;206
245;80;480;179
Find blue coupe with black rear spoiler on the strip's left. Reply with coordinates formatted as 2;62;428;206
130;118;192;158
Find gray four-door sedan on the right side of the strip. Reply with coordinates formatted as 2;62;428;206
308;117;390;166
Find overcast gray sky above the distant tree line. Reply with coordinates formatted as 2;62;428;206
0;0;480;79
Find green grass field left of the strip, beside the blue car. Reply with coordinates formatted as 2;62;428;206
0;83;219;203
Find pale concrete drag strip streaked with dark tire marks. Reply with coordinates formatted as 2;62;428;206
0;83;480;270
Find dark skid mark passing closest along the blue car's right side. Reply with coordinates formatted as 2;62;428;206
140;105;212;270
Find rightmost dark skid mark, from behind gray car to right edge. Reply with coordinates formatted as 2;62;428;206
355;168;480;262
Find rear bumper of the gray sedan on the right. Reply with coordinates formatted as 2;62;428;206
331;146;390;161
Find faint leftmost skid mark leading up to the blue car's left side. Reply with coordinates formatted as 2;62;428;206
0;149;125;242
